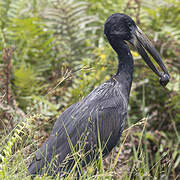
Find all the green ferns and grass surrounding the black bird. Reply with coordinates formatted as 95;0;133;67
0;0;180;180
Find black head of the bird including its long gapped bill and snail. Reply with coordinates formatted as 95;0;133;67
104;13;170;86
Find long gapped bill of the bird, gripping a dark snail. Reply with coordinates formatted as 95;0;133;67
131;26;170;86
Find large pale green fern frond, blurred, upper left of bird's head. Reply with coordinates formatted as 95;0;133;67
43;0;98;67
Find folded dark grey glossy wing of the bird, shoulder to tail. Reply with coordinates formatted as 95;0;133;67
28;81;128;174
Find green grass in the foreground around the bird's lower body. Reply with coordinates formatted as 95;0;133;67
0;88;180;180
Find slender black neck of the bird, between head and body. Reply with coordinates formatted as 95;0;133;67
111;41;134;96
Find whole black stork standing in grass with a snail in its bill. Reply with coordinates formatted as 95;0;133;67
28;13;170;176
